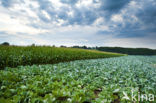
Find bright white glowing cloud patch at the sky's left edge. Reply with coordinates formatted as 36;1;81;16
0;12;46;34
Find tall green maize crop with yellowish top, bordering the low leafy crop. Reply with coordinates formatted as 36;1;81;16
0;46;123;69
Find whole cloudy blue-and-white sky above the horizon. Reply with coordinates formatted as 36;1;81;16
0;0;156;49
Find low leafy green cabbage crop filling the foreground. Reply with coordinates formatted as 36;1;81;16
0;56;156;103
